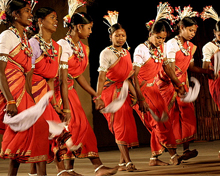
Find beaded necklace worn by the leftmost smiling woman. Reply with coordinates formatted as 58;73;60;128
9;26;33;57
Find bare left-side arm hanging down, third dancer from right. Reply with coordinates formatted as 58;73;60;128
134;66;149;113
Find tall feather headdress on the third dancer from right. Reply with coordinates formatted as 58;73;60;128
146;2;175;29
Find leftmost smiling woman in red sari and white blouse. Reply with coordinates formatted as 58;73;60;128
0;0;49;175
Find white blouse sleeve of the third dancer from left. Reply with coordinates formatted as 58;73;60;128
57;39;73;62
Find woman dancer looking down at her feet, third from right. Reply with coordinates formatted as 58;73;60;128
133;3;185;166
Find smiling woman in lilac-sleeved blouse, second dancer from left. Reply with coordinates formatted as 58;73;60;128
30;7;70;176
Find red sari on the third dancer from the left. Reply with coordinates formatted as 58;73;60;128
55;42;98;158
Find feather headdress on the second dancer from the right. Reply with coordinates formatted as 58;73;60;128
175;5;199;21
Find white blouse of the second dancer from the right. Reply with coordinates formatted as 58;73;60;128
167;38;194;62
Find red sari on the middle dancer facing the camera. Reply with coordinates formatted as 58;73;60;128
101;51;139;147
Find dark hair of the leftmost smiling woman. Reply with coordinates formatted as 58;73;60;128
5;0;28;23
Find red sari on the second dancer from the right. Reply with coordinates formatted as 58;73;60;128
157;42;196;144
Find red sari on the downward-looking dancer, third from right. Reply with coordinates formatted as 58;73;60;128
134;46;176;156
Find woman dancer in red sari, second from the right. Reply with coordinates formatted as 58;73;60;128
157;6;210;160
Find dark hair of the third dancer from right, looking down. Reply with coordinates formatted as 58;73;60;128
148;20;171;34
